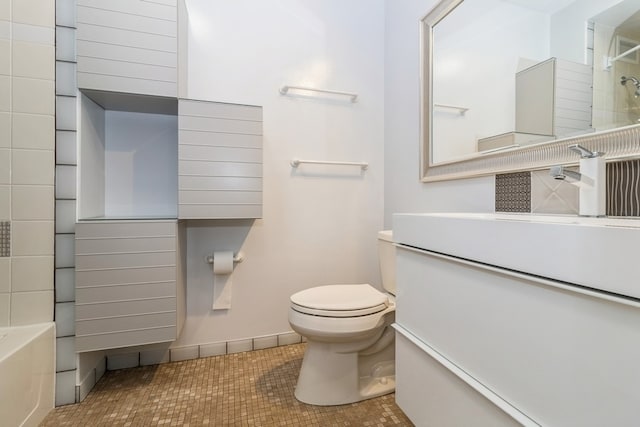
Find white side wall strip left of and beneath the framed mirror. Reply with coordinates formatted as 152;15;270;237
384;0;494;228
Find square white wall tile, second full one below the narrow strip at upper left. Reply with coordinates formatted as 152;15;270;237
11;77;56;115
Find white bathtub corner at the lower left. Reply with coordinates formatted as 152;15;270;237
0;322;56;427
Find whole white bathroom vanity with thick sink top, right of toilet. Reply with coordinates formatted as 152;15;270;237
393;214;640;427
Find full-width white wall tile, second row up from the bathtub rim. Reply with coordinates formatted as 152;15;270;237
11;256;54;292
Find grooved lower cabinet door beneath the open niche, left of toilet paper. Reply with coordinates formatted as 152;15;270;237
76;221;179;352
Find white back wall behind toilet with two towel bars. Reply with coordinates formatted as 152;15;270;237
174;0;384;346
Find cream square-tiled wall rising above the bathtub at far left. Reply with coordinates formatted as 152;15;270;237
0;0;55;326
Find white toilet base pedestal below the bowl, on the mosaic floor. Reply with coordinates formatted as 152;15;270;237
295;341;396;406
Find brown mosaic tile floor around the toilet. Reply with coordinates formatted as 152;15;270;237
41;344;413;427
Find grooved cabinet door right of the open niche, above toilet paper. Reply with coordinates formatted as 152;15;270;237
178;99;262;219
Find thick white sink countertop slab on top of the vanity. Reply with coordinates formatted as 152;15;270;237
393;213;640;299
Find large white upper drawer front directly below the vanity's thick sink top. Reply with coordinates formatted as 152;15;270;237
396;247;640;426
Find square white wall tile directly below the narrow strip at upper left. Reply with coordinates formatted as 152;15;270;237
11;41;56;80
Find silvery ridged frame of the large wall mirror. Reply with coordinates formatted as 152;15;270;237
420;0;640;182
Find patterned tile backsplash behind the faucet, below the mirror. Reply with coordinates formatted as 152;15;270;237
495;160;640;216
